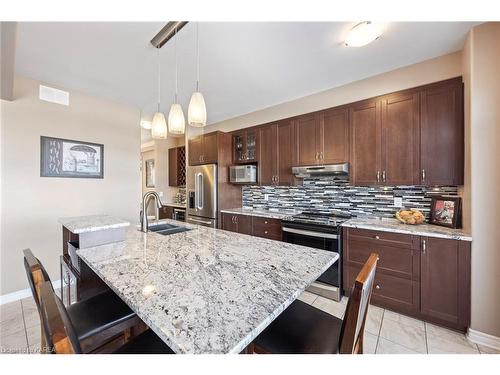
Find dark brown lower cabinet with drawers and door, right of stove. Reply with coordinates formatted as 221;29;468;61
343;228;470;331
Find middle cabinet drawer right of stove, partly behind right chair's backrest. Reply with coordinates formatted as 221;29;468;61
346;239;420;280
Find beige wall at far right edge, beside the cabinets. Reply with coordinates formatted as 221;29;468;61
464;22;500;337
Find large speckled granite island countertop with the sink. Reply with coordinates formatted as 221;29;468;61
78;220;338;353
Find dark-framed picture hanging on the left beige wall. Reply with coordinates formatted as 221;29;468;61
40;136;104;178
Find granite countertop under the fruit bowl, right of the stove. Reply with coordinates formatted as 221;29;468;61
342;217;472;241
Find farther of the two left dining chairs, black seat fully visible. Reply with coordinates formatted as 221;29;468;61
23;249;142;353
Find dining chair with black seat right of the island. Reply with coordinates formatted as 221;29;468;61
252;253;378;354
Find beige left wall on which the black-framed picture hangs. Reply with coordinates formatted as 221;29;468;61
0;77;140;295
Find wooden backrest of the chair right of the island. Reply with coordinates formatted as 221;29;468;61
340;253;378;354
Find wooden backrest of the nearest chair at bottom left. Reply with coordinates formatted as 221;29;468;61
40;281;82;354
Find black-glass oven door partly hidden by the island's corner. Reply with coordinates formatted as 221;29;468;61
282;226;341;288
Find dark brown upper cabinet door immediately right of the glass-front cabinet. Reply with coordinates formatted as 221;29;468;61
258;123;279;185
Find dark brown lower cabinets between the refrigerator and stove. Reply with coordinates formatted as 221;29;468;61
222;212;281;241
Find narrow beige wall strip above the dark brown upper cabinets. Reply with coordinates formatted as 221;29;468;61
206;51;462;134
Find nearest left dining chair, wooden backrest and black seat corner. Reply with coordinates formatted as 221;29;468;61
40;281;174;354
